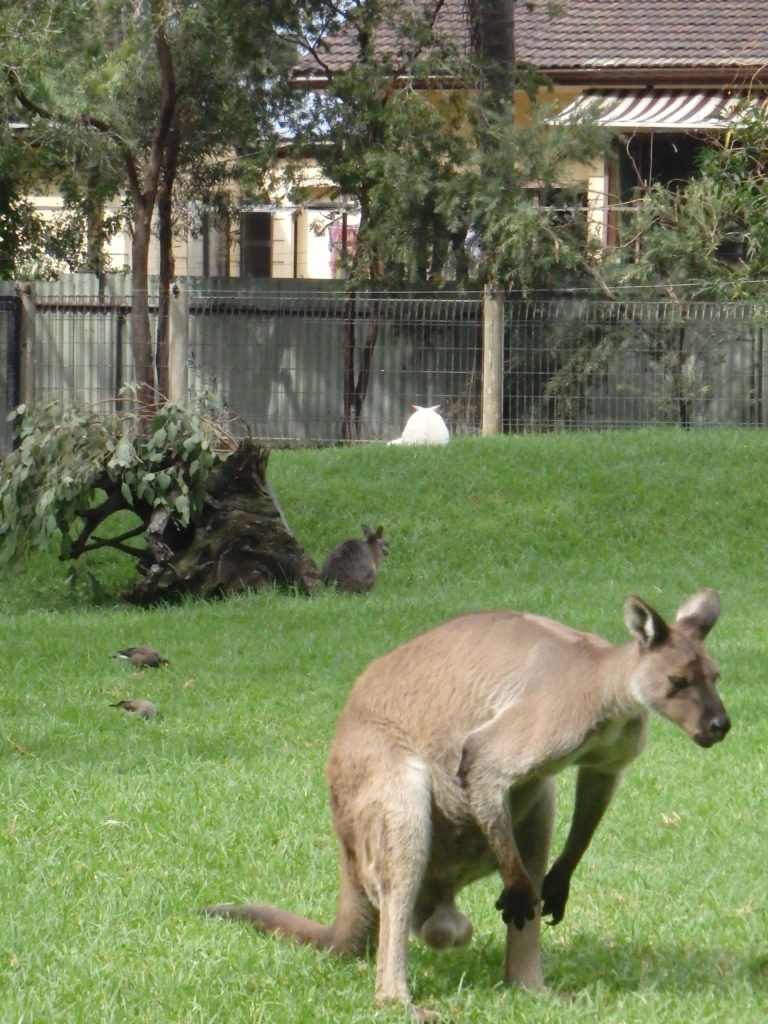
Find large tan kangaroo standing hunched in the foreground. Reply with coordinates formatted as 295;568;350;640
204;590;730;1020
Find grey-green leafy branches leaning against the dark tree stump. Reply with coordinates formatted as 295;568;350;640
0;402;231;563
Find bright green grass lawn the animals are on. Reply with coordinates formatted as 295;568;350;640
0;431;768;1024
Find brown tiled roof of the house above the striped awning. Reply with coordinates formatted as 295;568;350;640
302;0;768;81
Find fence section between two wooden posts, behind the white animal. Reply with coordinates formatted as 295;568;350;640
188;291;482;441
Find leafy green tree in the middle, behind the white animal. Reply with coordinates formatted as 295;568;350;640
280;0;602;437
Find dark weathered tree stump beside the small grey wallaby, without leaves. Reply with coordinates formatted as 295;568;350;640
123;440;321;605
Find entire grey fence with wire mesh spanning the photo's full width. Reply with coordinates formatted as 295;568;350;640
0;279;768;458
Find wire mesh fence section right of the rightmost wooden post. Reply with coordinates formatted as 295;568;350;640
505;299;768;431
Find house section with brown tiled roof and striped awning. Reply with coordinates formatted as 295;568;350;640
290;0;768;258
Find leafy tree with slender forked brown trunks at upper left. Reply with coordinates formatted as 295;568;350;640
0;0;313;410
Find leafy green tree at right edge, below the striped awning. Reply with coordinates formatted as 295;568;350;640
532;97;768;426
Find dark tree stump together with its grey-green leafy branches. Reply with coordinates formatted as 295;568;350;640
0;402;319;603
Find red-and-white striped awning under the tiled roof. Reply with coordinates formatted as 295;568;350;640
555;89;753;131
